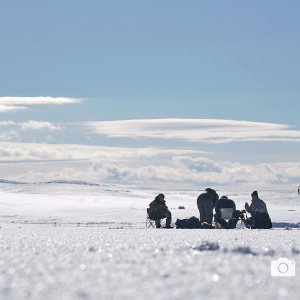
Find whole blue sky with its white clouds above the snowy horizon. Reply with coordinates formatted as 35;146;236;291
0;0;300;190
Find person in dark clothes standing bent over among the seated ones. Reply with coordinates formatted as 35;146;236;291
197;188;219;225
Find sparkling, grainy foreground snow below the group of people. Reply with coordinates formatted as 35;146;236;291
0;227;300;300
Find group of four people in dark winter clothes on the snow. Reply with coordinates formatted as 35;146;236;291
148;188;271;228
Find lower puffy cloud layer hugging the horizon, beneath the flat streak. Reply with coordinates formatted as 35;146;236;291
5;157;300;189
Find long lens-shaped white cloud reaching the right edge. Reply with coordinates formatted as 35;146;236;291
83;119;300;143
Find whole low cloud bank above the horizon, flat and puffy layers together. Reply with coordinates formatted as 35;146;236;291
0;143;300;189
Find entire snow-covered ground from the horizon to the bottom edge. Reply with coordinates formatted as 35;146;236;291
0;183;300;300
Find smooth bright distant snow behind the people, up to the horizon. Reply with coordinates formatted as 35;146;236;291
0;183;300;228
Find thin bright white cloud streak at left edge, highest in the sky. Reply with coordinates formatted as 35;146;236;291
0;96;83;113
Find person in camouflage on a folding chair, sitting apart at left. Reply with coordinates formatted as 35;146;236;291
148;194;173;228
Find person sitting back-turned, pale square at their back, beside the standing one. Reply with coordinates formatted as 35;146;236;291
214;196;240;229
